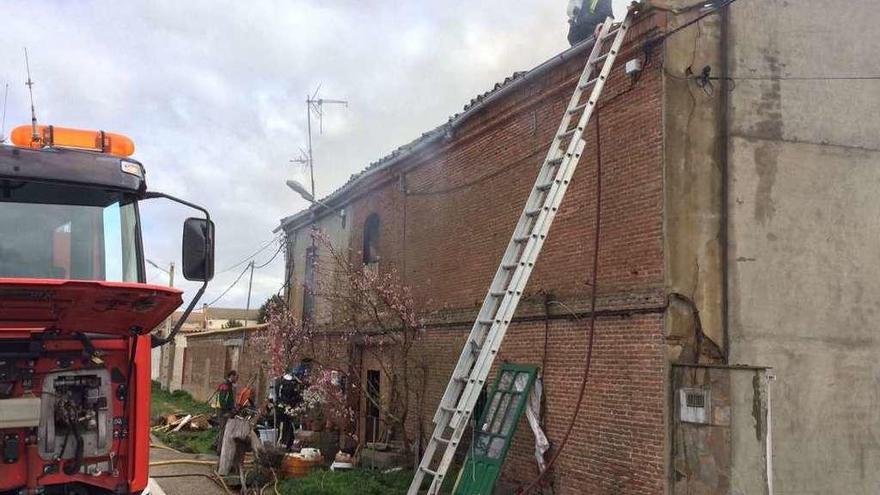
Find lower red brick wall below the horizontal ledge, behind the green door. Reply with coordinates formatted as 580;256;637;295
410;313;666;494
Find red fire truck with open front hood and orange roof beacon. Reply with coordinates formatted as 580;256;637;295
0;125;214;494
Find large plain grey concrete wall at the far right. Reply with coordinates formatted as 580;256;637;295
728;0;880;495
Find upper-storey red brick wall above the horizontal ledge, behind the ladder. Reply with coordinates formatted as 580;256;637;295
351;16;663;309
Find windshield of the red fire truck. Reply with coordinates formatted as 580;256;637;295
0;179;140;282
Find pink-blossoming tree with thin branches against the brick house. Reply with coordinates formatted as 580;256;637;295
253;230;427;454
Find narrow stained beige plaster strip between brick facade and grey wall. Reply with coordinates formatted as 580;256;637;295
655;0;725;362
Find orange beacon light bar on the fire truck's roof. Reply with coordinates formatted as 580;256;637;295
10;125;134;156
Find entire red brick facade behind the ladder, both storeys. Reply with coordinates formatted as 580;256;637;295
282;12;666;494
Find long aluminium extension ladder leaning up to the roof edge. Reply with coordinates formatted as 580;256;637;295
407;13;632;495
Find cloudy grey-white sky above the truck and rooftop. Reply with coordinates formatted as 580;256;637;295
0;0;628;307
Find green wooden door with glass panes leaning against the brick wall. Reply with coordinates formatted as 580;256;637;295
455;364;538;495
